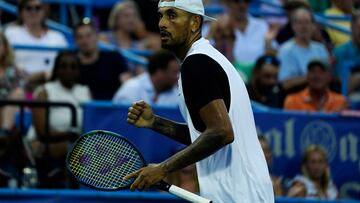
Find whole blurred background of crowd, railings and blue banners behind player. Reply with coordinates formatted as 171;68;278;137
0;0;360;203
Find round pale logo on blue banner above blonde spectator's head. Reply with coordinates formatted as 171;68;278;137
300;120;337;162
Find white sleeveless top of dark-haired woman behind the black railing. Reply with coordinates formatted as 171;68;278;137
27;81;91;140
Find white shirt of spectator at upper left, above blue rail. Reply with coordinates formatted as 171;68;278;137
5;25;68;73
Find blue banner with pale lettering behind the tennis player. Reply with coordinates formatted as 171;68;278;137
83;103;360;199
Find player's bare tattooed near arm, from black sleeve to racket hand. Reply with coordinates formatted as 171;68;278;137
125;99;234;190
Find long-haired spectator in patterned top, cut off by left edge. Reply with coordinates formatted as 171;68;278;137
0;32;26;187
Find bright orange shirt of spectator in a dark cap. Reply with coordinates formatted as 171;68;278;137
284;88;347;113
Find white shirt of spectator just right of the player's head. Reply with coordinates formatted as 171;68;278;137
233;16;269;64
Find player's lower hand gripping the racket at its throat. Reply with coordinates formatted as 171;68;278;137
124;164;167;191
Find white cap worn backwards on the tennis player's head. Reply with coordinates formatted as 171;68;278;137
158;0;216;21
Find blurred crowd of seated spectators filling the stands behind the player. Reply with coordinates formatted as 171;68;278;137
0;0;360;199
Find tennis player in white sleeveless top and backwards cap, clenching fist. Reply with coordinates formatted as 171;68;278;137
125;0;274;203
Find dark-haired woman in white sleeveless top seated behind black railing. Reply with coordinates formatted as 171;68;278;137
27;53;90;188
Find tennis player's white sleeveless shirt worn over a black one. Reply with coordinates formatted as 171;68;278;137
178;38;274;203
